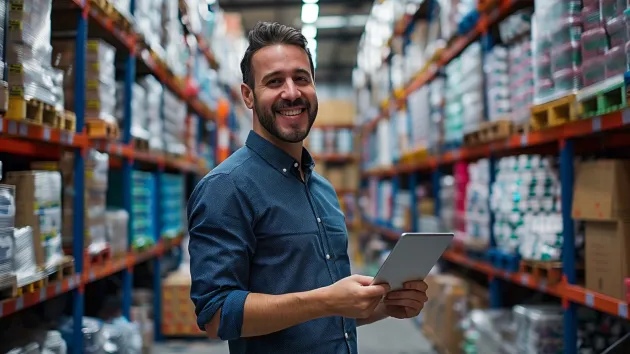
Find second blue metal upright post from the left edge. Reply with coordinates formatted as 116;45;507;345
122;0;136;320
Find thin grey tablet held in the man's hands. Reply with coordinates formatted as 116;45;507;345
372;233;454;290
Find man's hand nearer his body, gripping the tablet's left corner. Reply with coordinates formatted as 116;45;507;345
322;275;389;318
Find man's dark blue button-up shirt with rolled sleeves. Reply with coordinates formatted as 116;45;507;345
188;132;357;354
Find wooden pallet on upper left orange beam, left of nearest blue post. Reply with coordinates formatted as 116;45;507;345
5;96;60;128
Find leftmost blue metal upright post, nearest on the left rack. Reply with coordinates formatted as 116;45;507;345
71;4;88;353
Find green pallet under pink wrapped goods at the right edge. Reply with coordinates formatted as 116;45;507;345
577;75;628;118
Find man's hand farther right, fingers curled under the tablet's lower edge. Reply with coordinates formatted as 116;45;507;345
383;281;428;319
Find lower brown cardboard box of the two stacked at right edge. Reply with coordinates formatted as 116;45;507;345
585;221;630;300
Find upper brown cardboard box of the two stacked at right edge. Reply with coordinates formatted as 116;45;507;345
571;160;630;221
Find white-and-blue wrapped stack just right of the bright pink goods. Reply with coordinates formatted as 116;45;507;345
464;159;490;250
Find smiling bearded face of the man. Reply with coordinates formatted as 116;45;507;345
244;44;318;143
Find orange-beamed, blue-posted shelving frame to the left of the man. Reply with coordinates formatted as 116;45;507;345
0;0;242;353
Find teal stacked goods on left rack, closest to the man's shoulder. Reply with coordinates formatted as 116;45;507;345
159;174;186;238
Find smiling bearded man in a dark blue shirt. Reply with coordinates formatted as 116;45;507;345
188;23;427;354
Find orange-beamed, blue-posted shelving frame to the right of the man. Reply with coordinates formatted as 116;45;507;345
360;0;630;354
